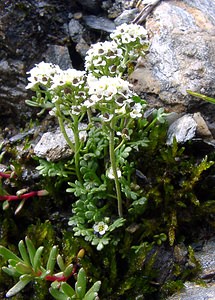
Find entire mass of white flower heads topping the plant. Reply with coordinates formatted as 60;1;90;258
26;24;147;122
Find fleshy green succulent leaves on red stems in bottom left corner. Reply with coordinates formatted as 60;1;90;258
0;237;101;300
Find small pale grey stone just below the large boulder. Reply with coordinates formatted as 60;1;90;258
166;114;197;145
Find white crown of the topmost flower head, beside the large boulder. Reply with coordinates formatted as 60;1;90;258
110;24;147;45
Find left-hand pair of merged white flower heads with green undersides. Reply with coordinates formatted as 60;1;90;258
26;62;88;115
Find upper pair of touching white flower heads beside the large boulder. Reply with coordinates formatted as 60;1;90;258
85;24;148;77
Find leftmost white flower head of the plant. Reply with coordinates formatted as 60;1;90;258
26;61;60;89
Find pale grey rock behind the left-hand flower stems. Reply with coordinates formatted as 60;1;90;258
34;124;86;161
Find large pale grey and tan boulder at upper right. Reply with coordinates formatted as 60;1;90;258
131;0;215;115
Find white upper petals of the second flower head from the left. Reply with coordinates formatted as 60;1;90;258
51;69;85;89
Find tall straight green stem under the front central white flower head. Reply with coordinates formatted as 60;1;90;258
109;118;122;217
